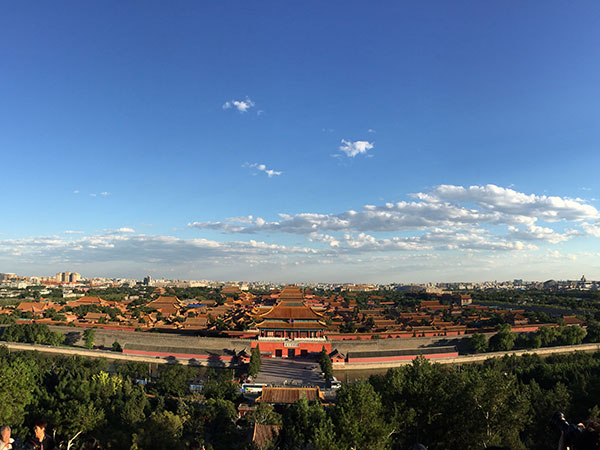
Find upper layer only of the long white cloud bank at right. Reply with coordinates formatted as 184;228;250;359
189;185;600;237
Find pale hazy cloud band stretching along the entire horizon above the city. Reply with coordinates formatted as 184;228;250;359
0;229;598;282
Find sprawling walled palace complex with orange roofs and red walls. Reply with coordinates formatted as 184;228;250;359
0;286;583;367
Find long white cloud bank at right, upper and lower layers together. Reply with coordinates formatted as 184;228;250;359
188;185;600;251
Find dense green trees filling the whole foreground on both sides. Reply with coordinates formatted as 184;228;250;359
0;347;600;450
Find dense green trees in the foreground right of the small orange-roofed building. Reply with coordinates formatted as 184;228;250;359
276;354;600;450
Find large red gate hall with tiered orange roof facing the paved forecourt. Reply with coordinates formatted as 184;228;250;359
252;286;331;358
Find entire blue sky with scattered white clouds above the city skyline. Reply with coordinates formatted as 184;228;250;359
0;1;600;282
